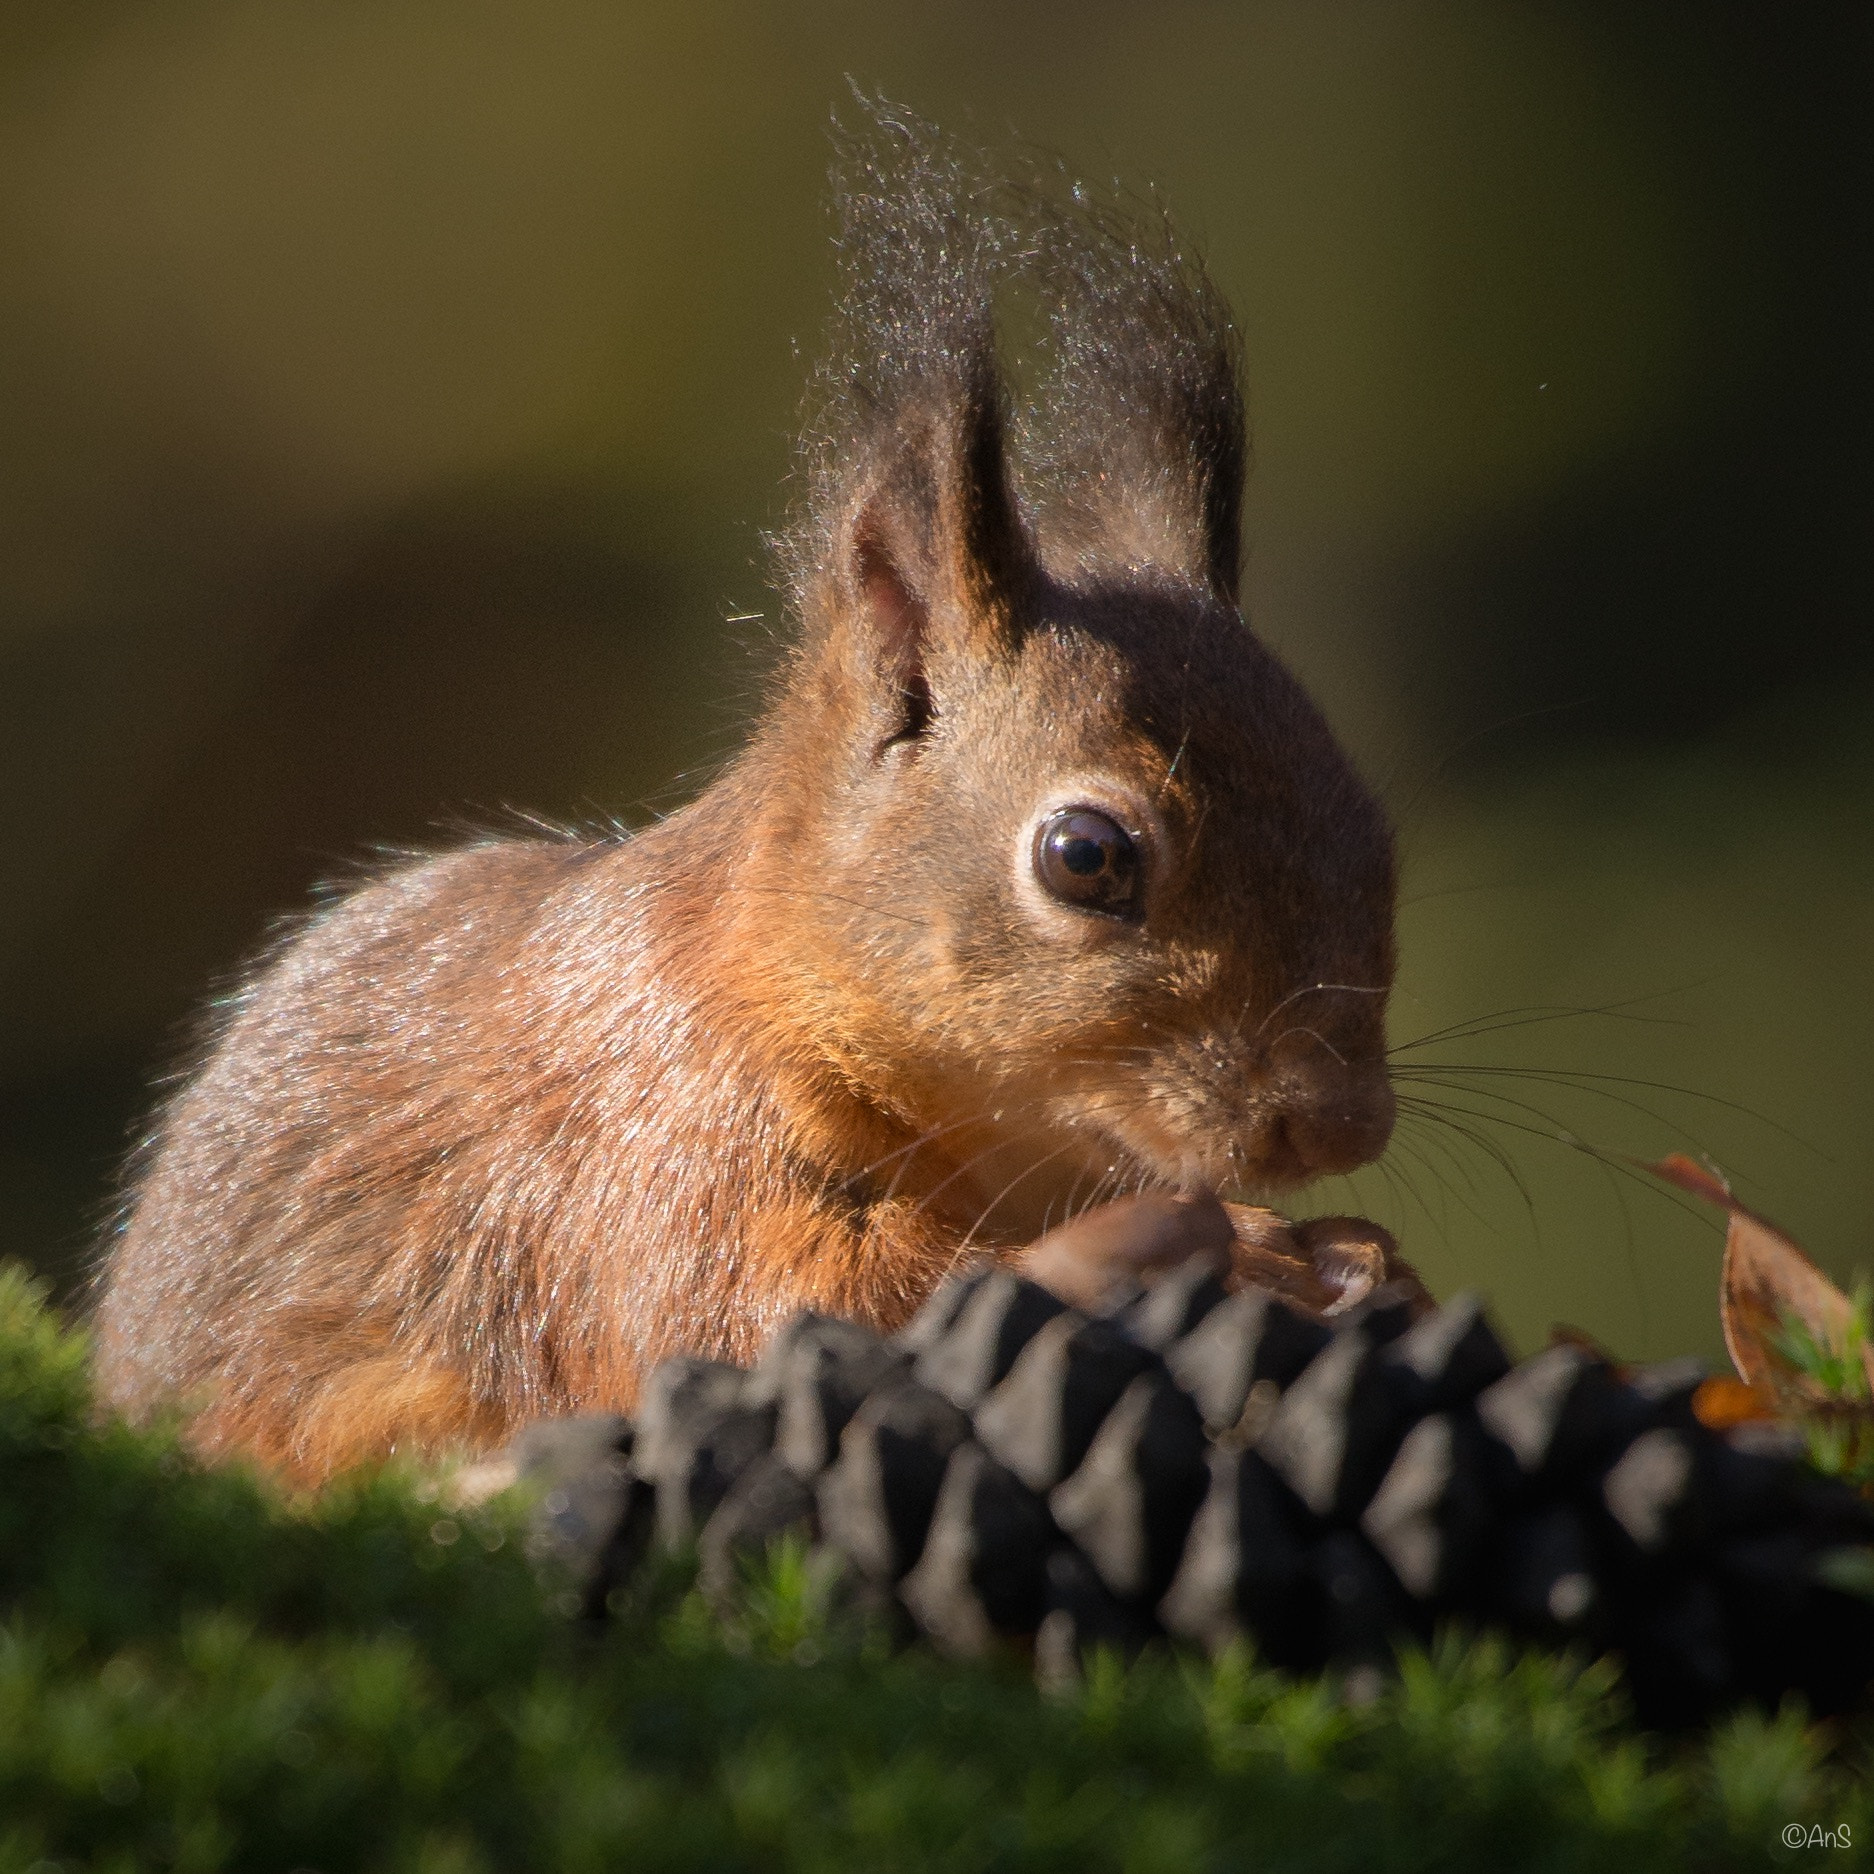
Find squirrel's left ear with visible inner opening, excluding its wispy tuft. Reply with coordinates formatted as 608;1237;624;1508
830;384;1027;742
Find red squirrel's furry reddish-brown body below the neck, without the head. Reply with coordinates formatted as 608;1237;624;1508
97;802;954;1471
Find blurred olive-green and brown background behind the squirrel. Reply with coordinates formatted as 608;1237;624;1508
0;0;1874;1355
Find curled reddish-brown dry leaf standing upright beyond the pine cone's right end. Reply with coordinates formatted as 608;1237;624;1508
1645;1153;1874;1411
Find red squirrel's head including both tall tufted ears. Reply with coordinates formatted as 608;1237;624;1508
748;116;1394;1233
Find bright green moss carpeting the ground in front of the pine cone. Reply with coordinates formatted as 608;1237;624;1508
0;1274;1874;1874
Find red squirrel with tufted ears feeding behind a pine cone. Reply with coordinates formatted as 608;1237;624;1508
96;111;1394;1480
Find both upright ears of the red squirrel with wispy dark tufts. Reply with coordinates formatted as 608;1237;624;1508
778;96;1246;667
